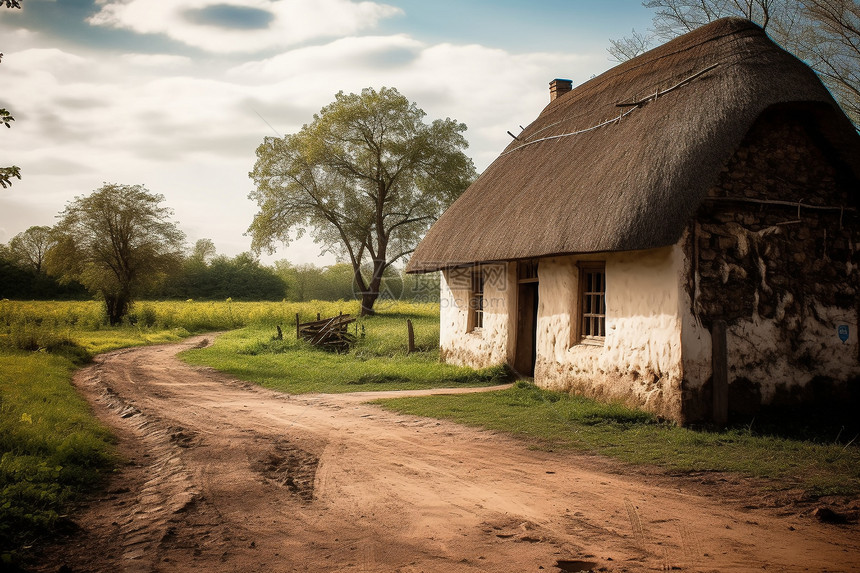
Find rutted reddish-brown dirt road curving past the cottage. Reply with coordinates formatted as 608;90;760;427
30;337;860;573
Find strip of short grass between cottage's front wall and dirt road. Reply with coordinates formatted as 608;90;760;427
378;382;860;496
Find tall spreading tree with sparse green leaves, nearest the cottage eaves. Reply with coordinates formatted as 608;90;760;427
249;88;475;315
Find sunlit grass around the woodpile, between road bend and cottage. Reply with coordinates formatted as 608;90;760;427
181;305;510;394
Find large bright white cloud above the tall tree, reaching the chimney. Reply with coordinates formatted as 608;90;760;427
224;35;605;169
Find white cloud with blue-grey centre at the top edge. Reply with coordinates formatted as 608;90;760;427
88;0;403;53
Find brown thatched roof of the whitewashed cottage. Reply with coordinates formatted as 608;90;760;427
407;15;860;272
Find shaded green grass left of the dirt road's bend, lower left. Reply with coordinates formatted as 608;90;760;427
0;349;115;564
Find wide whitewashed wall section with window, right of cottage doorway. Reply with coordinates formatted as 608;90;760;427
535;250;684;422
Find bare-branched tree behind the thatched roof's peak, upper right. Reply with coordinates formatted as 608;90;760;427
608;0;860;126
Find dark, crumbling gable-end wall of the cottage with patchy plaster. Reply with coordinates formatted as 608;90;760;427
681;108;860;419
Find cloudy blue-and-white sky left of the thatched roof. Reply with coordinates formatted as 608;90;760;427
0;0;652;266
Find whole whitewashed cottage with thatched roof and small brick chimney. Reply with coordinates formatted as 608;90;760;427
407;19;860;423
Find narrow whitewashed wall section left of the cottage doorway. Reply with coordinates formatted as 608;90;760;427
439;263;516;368
